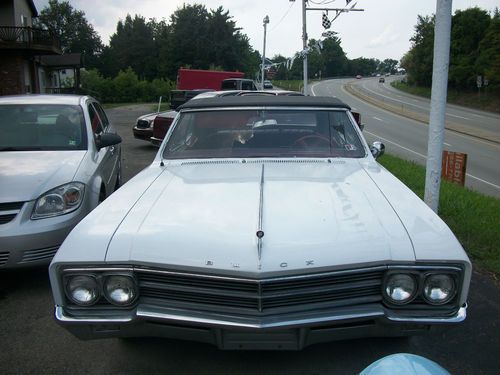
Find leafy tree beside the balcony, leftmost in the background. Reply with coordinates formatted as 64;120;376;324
39;0;103;67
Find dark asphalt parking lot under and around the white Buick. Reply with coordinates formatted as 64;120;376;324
0;106;500;375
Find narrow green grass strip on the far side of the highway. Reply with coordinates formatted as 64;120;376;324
391;81;500;113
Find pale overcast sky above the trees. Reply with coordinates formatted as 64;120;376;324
34;0;500;61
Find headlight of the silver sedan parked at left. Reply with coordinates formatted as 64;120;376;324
31;182;85;219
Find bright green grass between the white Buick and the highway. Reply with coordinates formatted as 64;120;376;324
378;154;500;280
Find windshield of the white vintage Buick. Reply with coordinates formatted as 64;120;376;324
163;109;365;159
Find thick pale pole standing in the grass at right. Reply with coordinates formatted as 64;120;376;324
424;0;452;212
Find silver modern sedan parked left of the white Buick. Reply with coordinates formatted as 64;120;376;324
0;95;121;269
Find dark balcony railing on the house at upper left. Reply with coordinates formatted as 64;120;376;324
0;26;61;53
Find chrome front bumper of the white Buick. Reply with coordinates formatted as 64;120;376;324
55;304;466;350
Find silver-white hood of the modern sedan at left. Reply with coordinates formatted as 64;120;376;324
0;151;86;202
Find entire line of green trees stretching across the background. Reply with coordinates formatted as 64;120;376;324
39;0;500;101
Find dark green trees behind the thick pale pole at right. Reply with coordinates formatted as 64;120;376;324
401;7;500;91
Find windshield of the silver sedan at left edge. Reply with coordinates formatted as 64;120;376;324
0;104;87;151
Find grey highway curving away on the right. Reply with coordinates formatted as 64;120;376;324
311;77;500;198
